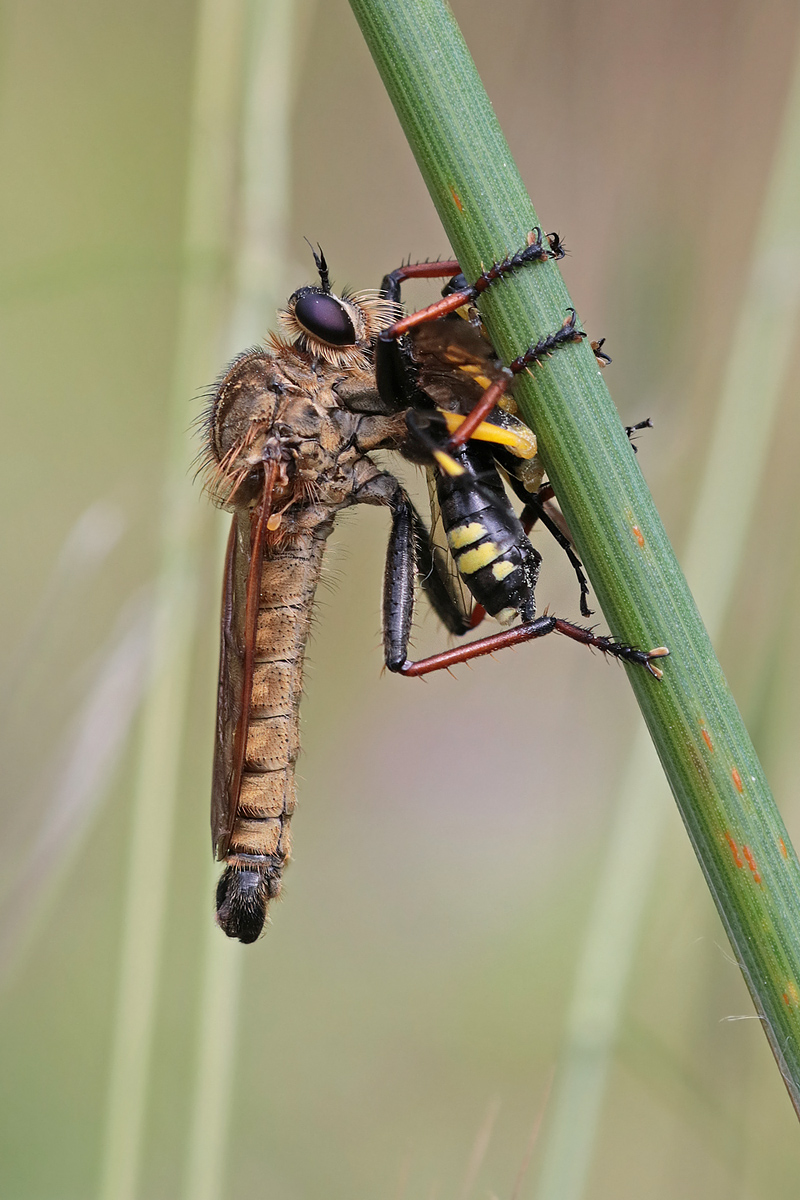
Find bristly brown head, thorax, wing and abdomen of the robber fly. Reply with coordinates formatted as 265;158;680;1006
204;253;470;942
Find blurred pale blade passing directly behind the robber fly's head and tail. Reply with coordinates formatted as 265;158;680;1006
185;0;306;1200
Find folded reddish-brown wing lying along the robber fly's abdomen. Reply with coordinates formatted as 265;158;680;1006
211;468;277;859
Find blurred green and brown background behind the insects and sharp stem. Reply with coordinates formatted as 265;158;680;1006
0;0;800;1200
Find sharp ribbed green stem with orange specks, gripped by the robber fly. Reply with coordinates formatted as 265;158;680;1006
350;0;800;1112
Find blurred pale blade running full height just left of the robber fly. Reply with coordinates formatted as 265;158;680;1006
100;0;241;1200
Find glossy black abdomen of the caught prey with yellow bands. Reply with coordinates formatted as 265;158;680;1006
437;449;541;624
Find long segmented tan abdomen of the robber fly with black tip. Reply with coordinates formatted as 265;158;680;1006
217;532;325;941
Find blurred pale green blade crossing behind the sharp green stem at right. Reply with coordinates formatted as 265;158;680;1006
537;30;800;1200
